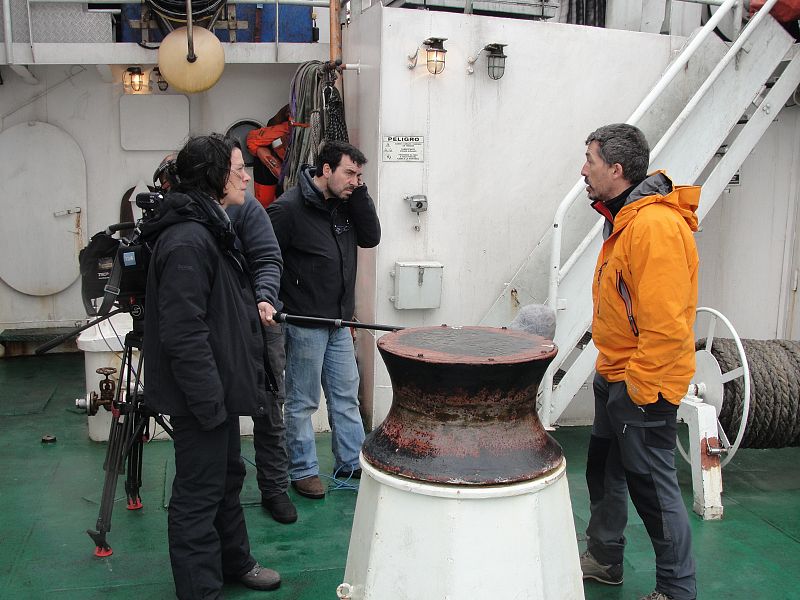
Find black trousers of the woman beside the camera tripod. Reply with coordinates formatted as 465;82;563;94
168;416;256;600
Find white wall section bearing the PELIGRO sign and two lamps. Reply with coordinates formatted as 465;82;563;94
345;5;692;425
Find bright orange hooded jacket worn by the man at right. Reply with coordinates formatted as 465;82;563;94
592;172;700;405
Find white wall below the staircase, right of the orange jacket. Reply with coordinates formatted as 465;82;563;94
696;106;800;339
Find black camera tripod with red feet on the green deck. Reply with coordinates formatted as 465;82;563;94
86;314;172;557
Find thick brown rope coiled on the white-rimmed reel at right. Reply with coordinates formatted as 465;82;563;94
695;338;800;448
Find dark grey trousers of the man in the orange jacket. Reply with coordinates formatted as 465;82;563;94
586;375;697;600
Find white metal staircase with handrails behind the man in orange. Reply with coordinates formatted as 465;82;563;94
481;0;800;427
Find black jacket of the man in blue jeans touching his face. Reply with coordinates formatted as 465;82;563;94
267;167;381;319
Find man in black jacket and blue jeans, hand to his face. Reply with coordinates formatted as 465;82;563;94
267;141;381;499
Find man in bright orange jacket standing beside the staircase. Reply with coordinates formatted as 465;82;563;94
581;123;700;600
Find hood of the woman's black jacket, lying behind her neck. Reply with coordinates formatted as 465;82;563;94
140;191;236;248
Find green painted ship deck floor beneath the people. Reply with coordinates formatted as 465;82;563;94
0;354;800;600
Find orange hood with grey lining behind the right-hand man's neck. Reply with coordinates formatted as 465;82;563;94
614;171;700;233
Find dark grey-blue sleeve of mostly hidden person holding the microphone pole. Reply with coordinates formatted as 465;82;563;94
225;192;283;310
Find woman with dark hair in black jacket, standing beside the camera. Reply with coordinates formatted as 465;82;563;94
142;134;281;600
